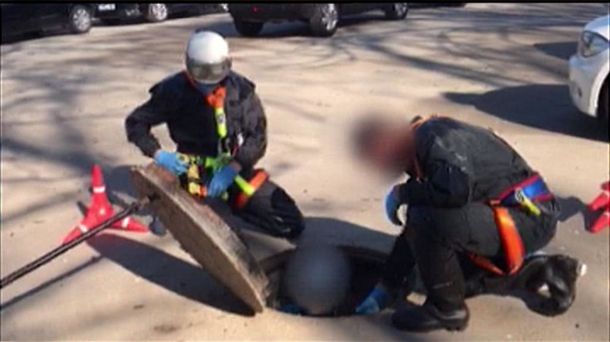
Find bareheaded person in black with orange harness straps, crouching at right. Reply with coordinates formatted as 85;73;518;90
354;117;580;331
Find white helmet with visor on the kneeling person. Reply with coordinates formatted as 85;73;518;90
186;31;231;84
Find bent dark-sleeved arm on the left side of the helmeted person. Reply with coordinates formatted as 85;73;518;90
125;82;175;158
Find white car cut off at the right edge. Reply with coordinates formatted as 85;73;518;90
570;15;610;123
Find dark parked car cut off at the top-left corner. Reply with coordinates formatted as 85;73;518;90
0;2;93;41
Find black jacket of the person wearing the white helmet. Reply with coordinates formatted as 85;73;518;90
125;72;267;168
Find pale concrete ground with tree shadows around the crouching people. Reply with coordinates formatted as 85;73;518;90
0;4;610;340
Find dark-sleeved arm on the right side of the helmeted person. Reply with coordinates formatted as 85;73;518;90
235;92;267;169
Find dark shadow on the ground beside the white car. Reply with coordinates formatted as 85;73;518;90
444;84;608;141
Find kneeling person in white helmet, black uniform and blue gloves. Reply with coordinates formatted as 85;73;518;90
125;31;304;238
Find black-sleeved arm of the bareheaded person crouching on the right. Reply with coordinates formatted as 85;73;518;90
399;132;473;207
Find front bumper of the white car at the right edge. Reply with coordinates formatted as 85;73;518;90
568;49;608;116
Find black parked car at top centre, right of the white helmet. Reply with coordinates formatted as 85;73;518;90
229;2;409;37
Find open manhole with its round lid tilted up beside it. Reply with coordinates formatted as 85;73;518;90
132;164;385;317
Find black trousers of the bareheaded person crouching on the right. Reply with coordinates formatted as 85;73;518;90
383;201;559;310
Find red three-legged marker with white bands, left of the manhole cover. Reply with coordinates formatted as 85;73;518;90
62;165;148;244
